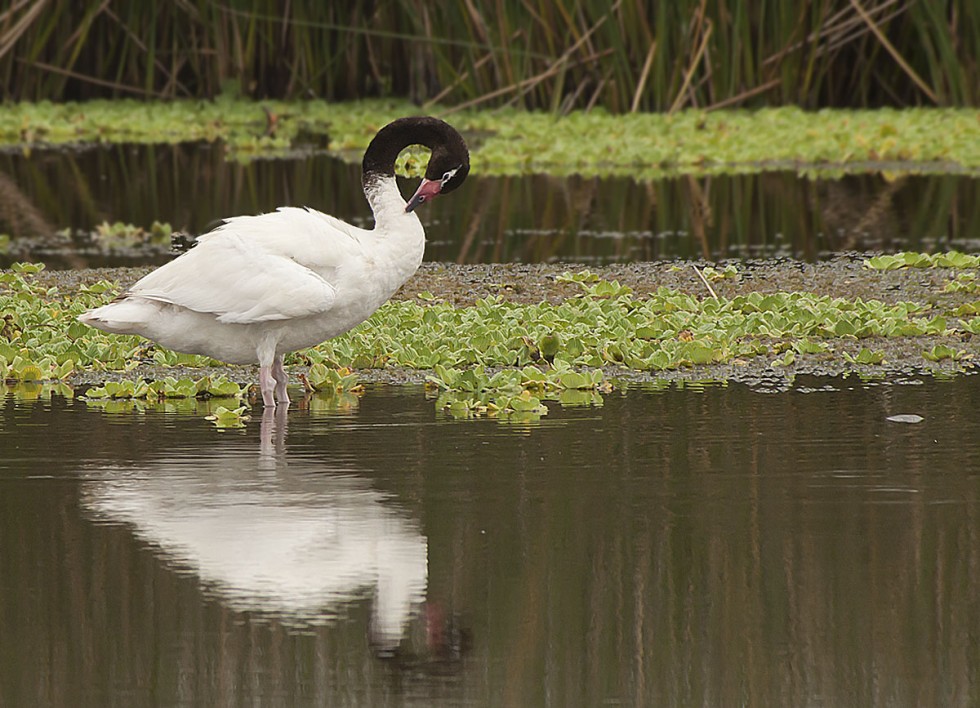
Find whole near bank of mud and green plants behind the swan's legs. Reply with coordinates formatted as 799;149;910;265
0;252;980;420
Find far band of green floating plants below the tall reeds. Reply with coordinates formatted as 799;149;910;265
0;97;980;180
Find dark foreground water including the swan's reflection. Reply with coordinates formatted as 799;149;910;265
0;376;980;707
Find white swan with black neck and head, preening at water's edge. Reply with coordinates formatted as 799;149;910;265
78;117;469;406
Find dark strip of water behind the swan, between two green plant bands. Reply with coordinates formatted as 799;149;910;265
0;144;980;267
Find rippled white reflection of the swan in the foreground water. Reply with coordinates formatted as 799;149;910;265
82;406;427;654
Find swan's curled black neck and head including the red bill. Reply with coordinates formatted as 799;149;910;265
362;116;470;211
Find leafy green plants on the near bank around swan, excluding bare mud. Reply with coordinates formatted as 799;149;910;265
0;265;980;411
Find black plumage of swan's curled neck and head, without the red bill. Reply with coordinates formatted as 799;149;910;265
361;116;470;192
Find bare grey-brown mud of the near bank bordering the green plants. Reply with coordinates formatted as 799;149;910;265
30;253;980;390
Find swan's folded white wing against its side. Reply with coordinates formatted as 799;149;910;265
125;234;337;324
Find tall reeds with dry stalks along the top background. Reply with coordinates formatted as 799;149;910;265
0;0;980;112
